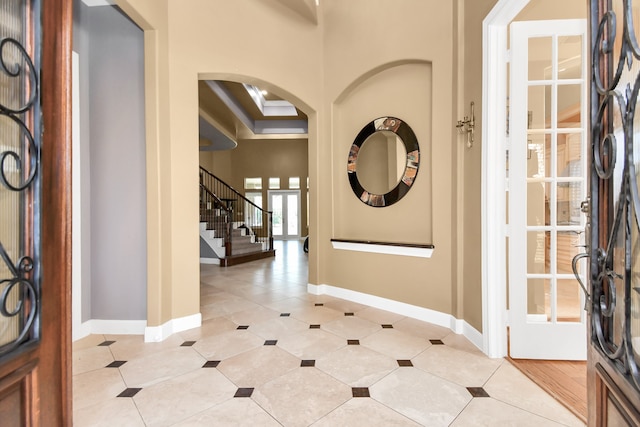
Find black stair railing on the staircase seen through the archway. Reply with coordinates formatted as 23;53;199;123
200;166;273;256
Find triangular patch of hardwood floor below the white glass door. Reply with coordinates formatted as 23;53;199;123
508;358;587;423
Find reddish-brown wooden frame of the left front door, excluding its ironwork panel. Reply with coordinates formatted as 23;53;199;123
0;0;73;426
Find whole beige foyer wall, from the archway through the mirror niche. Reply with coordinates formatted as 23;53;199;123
118;0;491;329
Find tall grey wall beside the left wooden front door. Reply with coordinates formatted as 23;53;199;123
74;0;147;322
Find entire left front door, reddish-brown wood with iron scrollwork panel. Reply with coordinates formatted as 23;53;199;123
0;0;72;427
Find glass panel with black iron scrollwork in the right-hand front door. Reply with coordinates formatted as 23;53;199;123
591;0;640;390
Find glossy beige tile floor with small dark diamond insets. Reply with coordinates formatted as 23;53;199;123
73;242;583;427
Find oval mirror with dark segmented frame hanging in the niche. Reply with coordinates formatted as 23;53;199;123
347;117;420;207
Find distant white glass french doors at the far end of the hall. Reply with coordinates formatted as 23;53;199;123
268;190;300;240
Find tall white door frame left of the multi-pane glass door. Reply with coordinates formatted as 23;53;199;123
481;0;529;357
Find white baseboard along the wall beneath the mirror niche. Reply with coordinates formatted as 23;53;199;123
307;284;483;350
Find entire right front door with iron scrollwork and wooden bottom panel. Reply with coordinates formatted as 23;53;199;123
588;0;640;426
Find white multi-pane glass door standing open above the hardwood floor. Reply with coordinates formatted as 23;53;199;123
508;19;587;360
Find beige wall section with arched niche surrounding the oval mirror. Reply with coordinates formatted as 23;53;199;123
320;0;457;313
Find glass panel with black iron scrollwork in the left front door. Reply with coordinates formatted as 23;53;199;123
0;4;41;357
